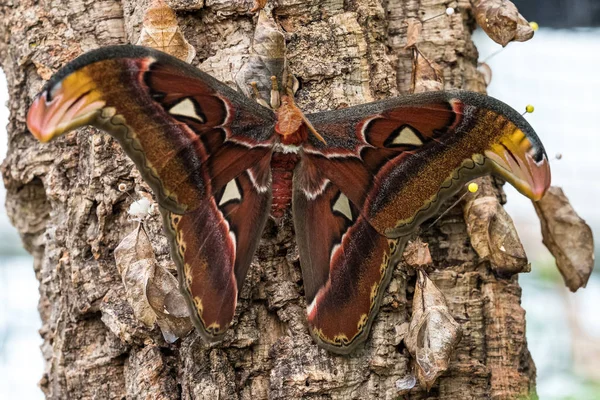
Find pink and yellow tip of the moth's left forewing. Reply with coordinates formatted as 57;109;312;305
27;68;105;142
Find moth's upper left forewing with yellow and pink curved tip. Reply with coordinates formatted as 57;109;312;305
27;45;275;214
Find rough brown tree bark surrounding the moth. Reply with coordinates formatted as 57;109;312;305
0;0;535;400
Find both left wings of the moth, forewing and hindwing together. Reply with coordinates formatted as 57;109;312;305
28;46;274;340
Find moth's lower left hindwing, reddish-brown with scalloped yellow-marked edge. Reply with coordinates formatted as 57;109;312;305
161;157;271;341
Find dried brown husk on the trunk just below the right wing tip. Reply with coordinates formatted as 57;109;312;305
463;185;529;276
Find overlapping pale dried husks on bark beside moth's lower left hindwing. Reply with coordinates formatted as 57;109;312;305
115;224;192;343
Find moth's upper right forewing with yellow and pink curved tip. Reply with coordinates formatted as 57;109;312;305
305;92;550;237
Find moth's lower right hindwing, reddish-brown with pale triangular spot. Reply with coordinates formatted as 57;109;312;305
293;156;397;354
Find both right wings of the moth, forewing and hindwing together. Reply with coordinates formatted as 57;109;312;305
293;92;550;354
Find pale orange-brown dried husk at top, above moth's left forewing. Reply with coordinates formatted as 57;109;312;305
137;0;196;63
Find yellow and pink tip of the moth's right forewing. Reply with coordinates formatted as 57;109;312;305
485;128;550;201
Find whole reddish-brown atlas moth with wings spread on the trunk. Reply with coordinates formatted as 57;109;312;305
27;10;550;354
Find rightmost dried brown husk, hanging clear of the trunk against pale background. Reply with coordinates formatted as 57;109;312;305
533;186;594;292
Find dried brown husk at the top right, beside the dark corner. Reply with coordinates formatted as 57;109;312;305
474;0;534;46
